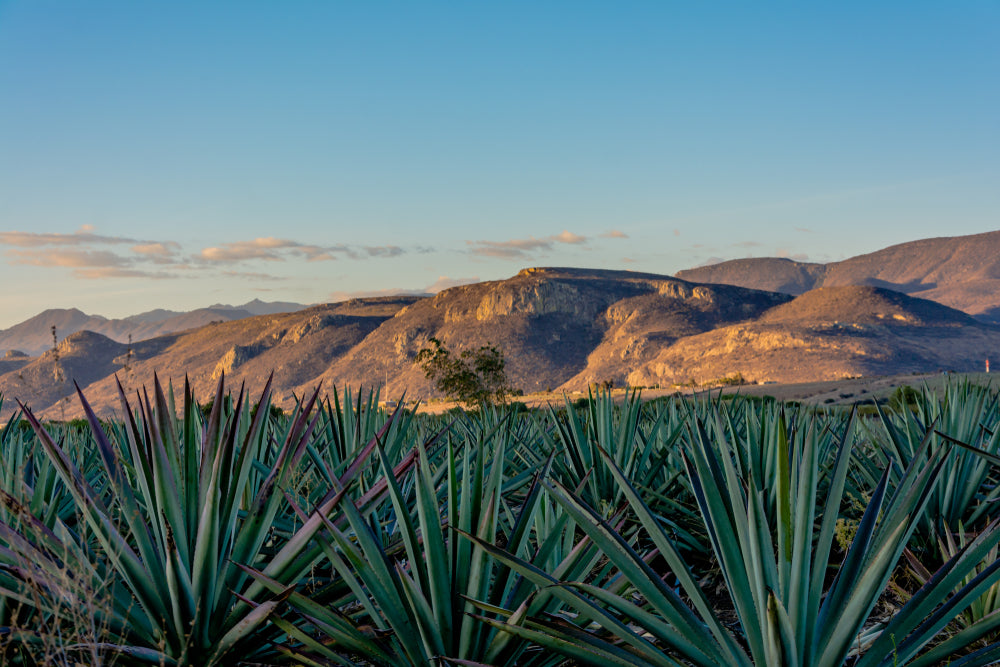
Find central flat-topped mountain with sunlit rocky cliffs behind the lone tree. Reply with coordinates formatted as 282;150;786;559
303;268;789;396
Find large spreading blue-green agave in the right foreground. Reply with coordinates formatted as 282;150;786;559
470;404;1000;667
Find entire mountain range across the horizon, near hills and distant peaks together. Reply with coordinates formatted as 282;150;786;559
0;232;1000;414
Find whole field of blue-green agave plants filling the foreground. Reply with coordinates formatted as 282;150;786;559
0;379;1000;667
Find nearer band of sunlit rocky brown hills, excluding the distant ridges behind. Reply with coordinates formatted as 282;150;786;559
0;258;1000;418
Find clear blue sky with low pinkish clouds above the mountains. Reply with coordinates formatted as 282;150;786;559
0;0;1000;328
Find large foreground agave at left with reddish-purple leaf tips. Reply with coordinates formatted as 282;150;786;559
5;378;340;665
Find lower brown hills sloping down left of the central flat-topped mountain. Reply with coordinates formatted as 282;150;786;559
0;297;416;418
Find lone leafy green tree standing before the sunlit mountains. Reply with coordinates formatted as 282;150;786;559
416;338;511;408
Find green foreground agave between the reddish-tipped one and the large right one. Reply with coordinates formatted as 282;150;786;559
250;404;597;666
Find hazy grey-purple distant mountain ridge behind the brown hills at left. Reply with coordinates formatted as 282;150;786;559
0;299;305;356
